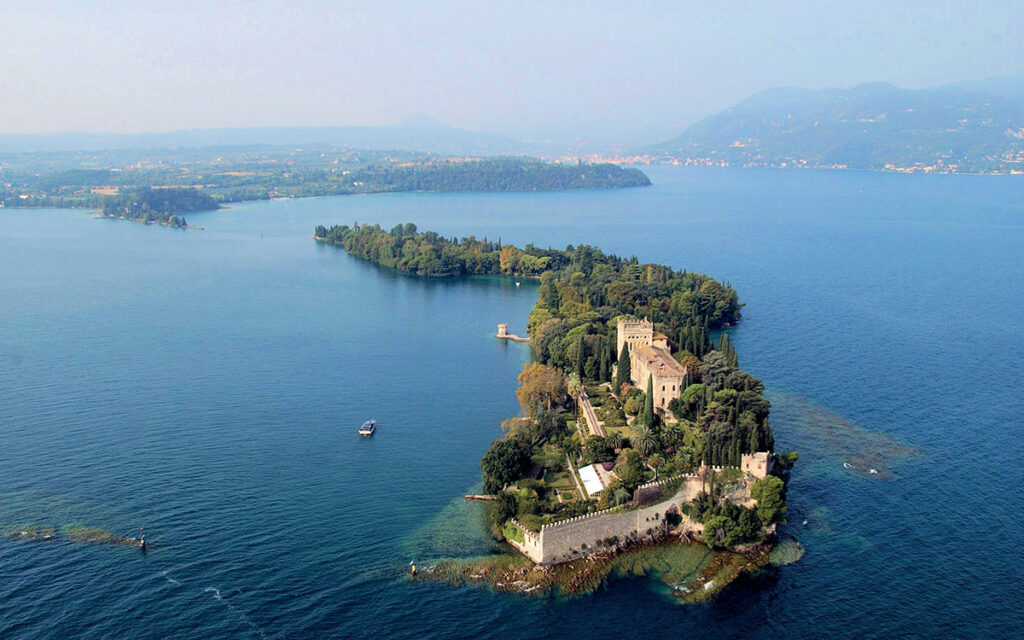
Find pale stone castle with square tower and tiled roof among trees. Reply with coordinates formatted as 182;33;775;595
616;317;686;411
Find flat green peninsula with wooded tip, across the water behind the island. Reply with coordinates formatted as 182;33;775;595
0;152;650;215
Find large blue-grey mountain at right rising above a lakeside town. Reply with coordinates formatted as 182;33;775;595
648;79;1024;173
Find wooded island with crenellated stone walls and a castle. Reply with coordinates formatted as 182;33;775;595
314;223;799;601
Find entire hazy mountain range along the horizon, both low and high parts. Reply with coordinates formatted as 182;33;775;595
0;75;1024;172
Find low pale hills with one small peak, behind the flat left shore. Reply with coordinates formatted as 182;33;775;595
0;122;531;155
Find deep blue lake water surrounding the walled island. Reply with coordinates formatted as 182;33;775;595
0;168;1024;639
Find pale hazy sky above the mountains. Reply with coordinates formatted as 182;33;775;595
0;0;1024;139
